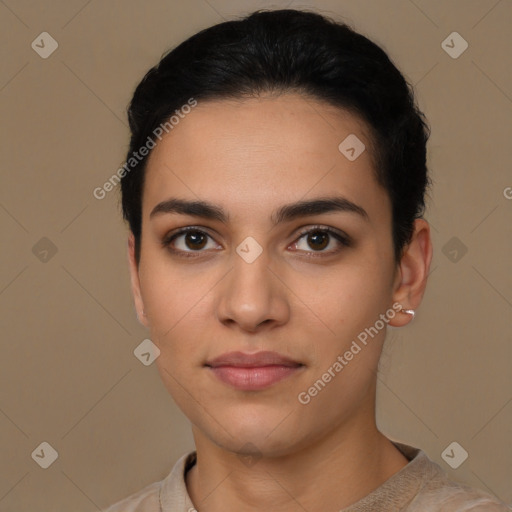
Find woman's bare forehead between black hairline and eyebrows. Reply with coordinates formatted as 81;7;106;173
143;94;389;226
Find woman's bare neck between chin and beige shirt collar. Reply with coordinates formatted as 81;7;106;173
186;414;408;512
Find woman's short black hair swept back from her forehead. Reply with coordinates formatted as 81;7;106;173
121;9;431;264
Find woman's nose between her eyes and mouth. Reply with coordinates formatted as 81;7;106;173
216;247;290;332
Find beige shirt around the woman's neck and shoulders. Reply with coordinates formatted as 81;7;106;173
103;442;512;512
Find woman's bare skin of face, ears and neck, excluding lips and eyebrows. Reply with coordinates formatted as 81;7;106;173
128;93;432;512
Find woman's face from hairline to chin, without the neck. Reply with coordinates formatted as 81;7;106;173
131;94;416;455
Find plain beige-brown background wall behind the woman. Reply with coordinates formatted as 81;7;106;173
0;0;512;512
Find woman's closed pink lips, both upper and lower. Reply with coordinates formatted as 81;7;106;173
205;351;304;391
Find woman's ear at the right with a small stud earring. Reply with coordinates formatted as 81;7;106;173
389;219;433;327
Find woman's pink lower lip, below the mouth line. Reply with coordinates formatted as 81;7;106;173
210;365;302;391
